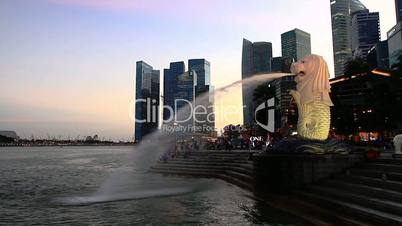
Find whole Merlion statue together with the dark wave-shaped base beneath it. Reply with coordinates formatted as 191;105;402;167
271;55;351;154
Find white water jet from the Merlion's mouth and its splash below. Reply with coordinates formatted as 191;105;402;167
62;73;290;205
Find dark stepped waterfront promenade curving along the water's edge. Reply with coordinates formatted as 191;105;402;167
151;151;402;225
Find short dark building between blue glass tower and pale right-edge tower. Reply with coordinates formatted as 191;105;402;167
367;40;389;70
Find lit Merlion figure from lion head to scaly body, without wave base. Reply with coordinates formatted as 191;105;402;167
290;55;333;141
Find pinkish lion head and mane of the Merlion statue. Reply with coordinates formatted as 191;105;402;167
291;54;333;106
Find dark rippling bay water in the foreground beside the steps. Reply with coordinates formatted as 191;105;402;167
0;147;308;225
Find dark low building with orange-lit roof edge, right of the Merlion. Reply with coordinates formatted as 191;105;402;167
330;70;402;137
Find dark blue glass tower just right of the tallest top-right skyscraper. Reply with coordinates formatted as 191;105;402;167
351;9;381;59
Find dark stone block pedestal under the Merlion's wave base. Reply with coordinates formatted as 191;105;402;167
253;153;363;192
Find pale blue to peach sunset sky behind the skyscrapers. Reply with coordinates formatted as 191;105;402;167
0;0;396;140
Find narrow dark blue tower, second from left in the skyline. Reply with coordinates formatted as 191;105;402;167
163;61;185;120
